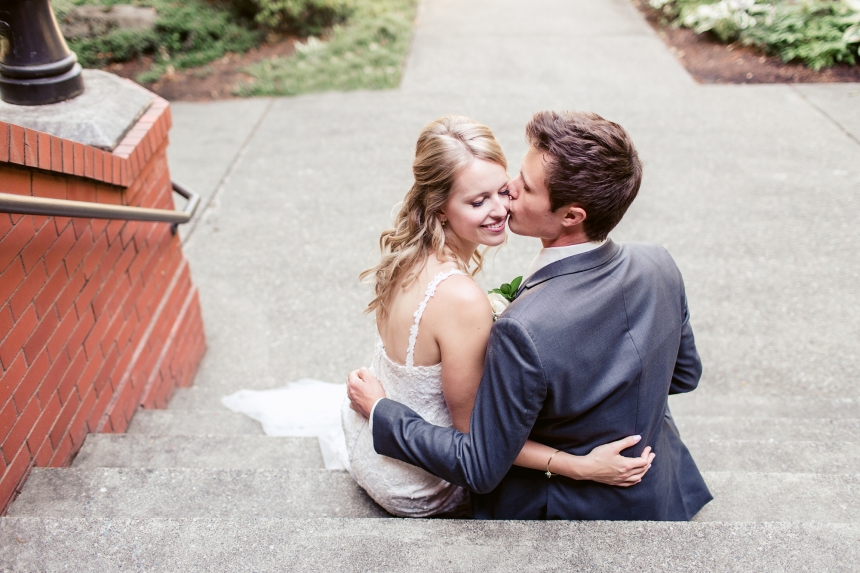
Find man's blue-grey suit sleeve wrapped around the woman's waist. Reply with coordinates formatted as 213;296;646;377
373;318;546;493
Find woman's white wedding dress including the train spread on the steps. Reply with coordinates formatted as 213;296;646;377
221;269;469;517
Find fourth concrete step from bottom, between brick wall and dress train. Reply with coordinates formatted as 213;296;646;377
128;408;263;436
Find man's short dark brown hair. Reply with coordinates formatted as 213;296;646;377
526;111;642;241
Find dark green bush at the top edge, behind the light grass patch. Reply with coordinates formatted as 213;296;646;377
254;0;353;36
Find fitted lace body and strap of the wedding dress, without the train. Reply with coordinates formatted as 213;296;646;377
341;270;469;517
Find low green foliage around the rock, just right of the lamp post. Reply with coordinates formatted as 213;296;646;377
55;0;261;82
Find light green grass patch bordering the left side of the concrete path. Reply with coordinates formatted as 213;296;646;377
236;0;417;96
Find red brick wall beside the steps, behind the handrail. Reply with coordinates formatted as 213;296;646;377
0;91;206;512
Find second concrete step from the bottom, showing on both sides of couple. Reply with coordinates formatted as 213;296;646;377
9;468;860;523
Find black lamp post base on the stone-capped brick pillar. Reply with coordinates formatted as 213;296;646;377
0;0;84;105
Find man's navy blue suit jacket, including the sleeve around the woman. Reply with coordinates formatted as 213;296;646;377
373;241;712;520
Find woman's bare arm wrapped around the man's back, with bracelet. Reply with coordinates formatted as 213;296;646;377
434;277;654;486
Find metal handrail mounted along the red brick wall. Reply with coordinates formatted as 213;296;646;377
0;181;200;234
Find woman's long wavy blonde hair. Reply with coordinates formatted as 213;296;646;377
361;115;508;317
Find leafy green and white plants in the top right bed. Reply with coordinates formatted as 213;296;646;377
649;0;860;70
